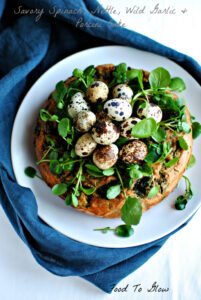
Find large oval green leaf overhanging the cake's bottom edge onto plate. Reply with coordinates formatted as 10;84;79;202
121;197;142;225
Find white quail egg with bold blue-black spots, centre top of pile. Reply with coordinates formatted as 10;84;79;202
103;99;132;121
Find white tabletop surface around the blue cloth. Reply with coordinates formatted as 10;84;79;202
0;0;201;300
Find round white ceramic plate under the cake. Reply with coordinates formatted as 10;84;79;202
11;46;201;248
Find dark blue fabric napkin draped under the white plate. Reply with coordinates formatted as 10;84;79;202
0;0;201;293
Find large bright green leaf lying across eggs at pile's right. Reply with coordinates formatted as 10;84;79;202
131;118;157;138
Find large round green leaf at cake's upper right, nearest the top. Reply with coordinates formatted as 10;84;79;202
149;67;171;89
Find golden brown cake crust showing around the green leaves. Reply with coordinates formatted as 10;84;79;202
34;64;193;218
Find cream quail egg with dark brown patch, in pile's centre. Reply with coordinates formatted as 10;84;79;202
91;122;119;145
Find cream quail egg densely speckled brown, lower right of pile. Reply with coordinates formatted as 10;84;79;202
119;141;148;164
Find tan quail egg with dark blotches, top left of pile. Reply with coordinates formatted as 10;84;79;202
86;80;109;103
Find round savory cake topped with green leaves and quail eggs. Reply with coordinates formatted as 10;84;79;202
34;63;193;231
